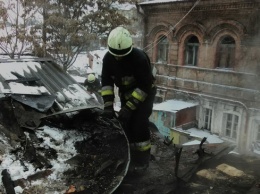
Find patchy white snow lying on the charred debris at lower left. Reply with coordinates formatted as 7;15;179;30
0;126;81;194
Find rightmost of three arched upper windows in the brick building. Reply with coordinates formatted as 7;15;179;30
216;36;235;68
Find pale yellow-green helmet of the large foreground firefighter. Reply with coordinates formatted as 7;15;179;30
107;27;133;57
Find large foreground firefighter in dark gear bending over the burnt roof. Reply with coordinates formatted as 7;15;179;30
101;27;156;171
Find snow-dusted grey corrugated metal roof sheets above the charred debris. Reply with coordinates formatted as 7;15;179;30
0;59;101;112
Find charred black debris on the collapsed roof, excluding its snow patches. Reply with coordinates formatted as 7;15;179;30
0;98;129;193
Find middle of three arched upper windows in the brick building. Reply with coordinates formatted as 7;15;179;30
185;36;199;66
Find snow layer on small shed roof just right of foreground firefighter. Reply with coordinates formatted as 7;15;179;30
153;100;198;113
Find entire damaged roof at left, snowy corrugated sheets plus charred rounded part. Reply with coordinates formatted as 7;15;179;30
0;59;130;194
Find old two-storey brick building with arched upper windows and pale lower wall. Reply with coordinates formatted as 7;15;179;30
138;0;260;154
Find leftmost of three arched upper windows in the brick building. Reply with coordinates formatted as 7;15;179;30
156;35;169;62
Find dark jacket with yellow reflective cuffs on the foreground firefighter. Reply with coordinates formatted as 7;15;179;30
101;48;154;110
